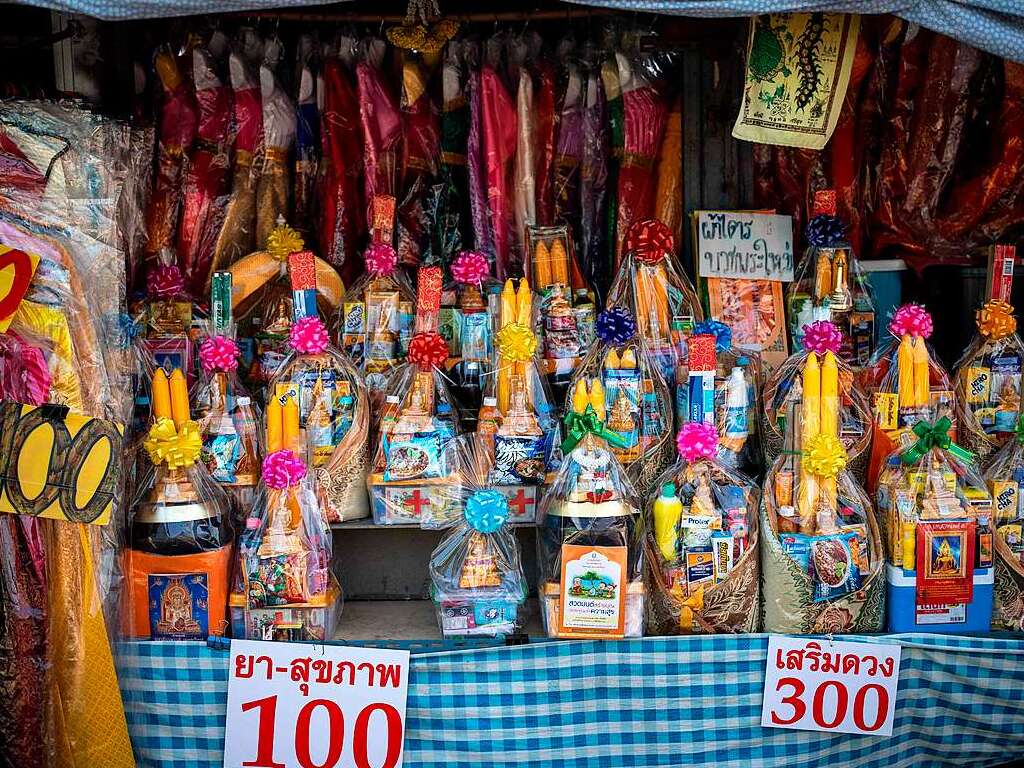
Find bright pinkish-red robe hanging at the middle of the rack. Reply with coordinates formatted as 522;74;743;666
480;63;516;281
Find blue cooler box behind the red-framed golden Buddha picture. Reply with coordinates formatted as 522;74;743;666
886;563;994;635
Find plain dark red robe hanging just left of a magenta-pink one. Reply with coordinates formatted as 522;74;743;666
319;58;367;286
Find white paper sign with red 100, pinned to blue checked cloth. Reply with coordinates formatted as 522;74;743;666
224;640;409;768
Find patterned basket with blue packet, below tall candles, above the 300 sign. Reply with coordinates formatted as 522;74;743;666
760;454;886;634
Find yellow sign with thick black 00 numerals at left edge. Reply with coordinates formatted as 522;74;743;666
0;400;124;525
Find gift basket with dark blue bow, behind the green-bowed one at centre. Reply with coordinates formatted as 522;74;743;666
566;307;674;493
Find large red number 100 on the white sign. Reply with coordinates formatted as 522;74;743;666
242;696;401;768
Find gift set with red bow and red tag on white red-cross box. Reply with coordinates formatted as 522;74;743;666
368;267;461;526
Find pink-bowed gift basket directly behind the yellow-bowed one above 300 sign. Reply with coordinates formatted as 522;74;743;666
761;321;871;483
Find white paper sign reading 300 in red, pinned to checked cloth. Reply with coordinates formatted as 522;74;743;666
761;635;900;736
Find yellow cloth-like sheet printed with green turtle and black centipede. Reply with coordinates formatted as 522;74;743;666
732;12;860;150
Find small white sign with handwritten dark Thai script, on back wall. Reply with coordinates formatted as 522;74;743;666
697;211;793;283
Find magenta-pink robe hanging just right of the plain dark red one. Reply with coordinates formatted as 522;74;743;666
355;41;401;228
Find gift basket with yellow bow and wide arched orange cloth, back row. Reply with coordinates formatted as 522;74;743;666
229;222;345;387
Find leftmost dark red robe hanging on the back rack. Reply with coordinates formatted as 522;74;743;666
145;51;199;264
